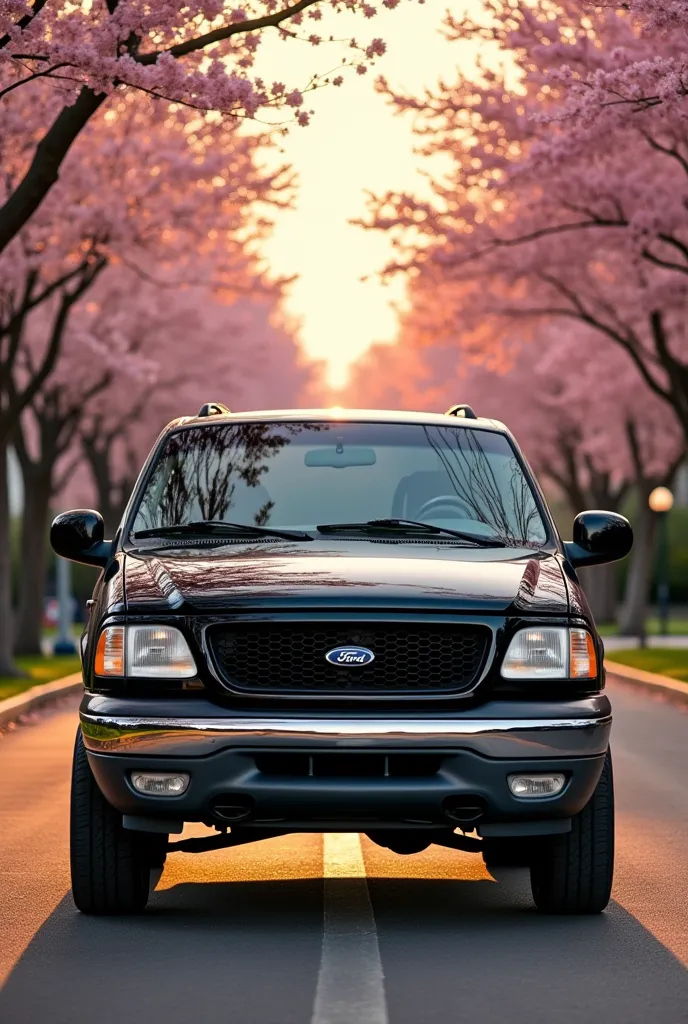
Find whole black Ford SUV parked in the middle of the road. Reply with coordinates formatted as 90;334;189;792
51;403;633;913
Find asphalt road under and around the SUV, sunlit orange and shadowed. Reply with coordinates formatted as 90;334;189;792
0;684;688;1024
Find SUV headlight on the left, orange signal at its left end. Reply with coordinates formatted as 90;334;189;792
95;626;197;679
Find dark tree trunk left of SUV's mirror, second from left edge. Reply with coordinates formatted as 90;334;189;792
14;467;52;654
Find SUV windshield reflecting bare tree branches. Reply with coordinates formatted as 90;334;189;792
133;422;547;547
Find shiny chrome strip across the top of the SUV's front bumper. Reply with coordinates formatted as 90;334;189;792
81;705;611;759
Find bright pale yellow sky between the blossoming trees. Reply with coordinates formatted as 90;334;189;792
253;0;477;386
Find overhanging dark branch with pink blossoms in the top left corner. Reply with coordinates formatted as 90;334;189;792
0;0;400;252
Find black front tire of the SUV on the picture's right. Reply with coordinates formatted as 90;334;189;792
530;751;614;913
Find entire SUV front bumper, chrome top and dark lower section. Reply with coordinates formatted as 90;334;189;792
81;695;611;835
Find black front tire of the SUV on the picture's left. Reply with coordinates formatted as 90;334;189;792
70;729;167;914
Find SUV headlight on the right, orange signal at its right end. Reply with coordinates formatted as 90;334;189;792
502;626;597;679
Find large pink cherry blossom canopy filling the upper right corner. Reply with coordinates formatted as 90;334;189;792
371;0;688;436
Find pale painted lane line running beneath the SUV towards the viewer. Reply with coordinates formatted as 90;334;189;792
311;833;388;1024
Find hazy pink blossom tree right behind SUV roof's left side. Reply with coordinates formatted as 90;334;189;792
73;289;321;532
